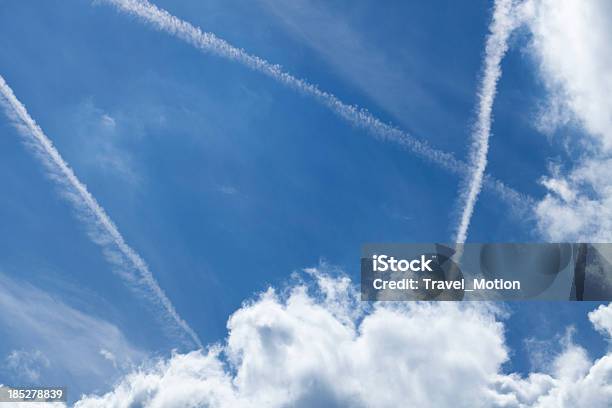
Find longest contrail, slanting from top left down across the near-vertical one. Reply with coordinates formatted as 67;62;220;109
100;0;533;214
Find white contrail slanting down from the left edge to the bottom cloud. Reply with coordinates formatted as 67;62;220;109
0;75;202;348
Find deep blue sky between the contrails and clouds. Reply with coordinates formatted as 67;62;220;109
0;0;606;404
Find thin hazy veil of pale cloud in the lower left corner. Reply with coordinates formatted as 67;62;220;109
0;274;144;392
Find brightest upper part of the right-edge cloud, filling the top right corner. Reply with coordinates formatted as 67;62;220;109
523;0;612;150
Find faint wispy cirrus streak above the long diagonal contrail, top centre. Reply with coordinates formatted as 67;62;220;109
257;0;450;134
